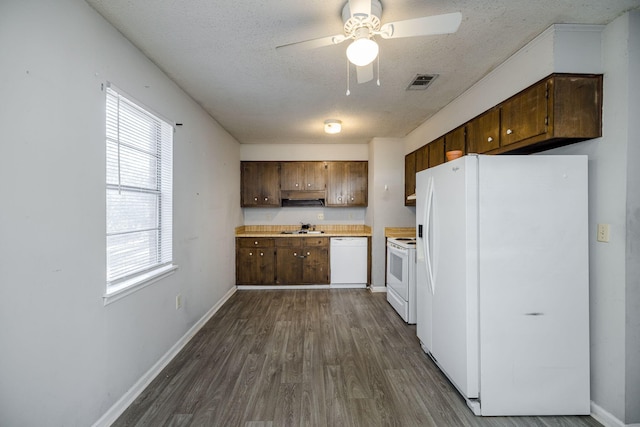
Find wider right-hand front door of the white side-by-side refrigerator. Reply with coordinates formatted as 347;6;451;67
424;156;479;398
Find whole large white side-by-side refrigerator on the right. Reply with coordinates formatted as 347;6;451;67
416;155;590;415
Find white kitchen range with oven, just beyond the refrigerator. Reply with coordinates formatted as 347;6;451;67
387;237;416;324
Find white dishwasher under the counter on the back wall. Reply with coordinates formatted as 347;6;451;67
330;237;368;288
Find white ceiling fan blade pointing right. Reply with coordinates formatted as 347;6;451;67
380;12;462;39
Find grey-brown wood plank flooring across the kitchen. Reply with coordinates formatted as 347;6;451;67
114;289;600;427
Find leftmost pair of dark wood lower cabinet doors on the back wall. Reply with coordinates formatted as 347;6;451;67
236;247;275;285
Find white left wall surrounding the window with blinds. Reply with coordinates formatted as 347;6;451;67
0;0;242;426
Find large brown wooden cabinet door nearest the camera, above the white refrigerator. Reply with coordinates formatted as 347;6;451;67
500;81;548;147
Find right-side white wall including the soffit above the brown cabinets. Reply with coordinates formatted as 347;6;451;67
405;15;640;423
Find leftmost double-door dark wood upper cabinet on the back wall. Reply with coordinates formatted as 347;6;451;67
240;162;280;207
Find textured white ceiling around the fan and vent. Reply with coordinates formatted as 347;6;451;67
86;0;640;143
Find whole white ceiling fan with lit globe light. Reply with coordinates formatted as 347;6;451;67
276;0;462;83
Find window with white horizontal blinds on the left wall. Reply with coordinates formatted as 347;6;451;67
106;87;173;294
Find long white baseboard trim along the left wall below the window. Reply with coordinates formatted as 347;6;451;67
93;286;237;427
